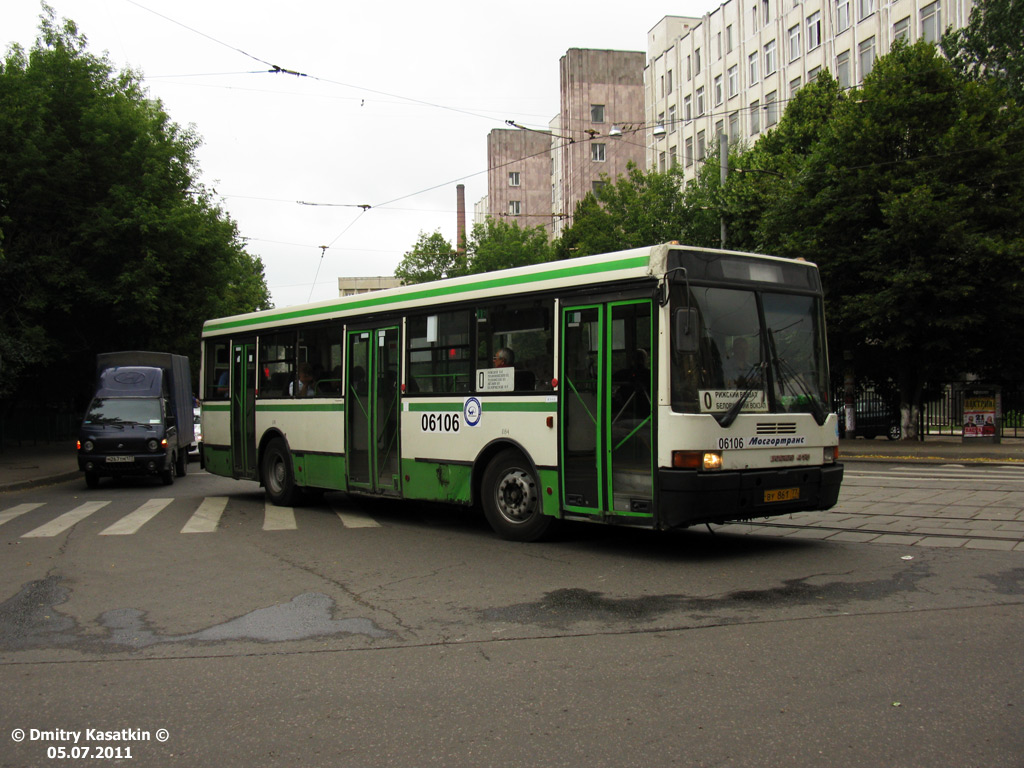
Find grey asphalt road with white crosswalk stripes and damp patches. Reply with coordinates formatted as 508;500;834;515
0;466;1024;768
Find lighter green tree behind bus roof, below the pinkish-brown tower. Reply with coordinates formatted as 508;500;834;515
556;163;690;258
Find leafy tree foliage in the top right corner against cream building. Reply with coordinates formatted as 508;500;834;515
942;0;1024;105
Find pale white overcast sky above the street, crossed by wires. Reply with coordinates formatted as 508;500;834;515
6;0;719;307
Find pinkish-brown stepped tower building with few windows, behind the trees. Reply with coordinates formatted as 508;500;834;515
474;48;646;238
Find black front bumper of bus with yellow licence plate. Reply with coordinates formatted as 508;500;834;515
658;464;843;528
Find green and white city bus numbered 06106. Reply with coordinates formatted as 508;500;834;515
201;244;843;541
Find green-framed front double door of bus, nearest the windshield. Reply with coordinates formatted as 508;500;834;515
559;299;654;521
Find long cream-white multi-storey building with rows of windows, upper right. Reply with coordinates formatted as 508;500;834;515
644;0;973;178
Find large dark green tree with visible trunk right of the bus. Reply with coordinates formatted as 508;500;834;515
762;43;1024;438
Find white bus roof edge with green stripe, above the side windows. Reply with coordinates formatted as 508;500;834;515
203;243;813;337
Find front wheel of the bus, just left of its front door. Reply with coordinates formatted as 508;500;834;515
480;450;552;542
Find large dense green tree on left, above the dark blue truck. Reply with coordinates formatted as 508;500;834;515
0;6;269;407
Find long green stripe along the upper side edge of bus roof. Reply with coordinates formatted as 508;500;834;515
203;255;650;333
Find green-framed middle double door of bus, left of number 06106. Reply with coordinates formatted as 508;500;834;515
345;327;401;496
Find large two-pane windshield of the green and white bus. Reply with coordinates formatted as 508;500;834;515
671;285;828;426
